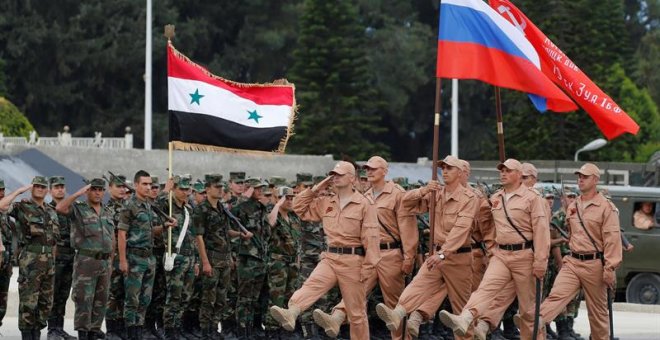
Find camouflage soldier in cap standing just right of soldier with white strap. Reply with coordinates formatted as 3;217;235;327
193;174;246;339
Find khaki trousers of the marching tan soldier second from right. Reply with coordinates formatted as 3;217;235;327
464;249;545;340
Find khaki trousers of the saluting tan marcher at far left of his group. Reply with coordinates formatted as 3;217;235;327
289;252;369;340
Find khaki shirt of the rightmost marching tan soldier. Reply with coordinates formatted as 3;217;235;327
566;193;623;270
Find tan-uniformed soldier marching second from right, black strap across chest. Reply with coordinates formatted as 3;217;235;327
440;159;550;339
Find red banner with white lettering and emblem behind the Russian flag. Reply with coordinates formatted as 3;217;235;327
489;0;639;140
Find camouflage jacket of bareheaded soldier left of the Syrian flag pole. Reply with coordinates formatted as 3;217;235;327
117;196;157;249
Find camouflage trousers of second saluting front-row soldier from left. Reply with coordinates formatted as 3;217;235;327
71;254;112;331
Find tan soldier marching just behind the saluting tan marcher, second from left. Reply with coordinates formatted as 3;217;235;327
314;156;419;339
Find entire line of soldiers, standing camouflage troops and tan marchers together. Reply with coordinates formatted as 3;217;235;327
0;156;621;339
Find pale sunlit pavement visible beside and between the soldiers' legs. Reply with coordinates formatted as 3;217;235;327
0;268;660;340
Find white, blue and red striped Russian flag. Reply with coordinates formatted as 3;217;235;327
437;0;577;112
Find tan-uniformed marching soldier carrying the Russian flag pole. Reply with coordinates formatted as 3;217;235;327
376;156;479;338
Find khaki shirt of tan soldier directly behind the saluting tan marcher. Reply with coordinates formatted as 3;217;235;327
364;181;419;262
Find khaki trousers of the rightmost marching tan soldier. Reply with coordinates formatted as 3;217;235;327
540;256;610;340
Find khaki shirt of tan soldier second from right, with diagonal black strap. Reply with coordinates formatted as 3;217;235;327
490;185;550;268
